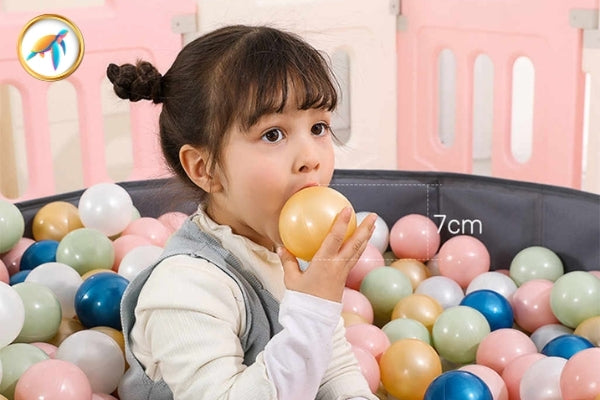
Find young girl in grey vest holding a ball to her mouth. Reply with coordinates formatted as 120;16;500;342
107;26;376;400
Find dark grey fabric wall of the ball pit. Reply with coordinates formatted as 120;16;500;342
5;170;600;398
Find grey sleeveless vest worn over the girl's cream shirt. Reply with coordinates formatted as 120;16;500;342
119;219;281;400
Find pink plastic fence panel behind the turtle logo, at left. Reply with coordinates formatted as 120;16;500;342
0;0;196;201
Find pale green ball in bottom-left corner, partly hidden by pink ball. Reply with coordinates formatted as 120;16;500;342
0;343;50;399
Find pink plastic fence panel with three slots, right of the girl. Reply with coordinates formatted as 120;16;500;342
397;0;598;188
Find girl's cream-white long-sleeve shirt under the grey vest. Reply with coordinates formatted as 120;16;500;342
131;209;377;400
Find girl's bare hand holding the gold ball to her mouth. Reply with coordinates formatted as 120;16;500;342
277;207;377;302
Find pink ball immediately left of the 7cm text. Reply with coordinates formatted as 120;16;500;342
390;214;440;262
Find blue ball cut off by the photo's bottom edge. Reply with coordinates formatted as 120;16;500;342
423;370;493;400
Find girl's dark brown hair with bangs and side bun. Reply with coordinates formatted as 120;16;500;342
107;25;337;196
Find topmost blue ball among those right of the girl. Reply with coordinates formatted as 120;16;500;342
460;289;514;331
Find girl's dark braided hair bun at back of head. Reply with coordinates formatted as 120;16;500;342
106;61;163;104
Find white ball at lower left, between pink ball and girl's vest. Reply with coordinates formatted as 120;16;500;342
54;329;125;393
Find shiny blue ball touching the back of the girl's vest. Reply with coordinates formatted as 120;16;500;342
75;272;129;330
